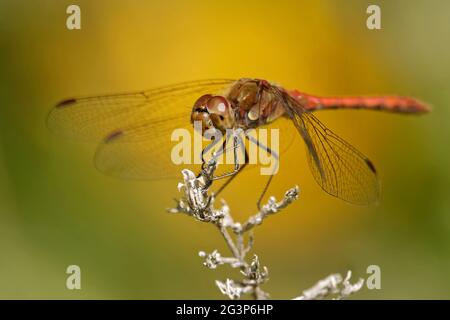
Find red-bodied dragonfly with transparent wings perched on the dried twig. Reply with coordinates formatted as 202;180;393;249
47;78;430;206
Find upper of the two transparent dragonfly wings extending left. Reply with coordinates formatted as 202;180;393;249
47;79;233;141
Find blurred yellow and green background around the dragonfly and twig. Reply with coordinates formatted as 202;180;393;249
0;0;450;299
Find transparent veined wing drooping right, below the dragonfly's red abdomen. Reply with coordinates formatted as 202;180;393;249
290;97;380;205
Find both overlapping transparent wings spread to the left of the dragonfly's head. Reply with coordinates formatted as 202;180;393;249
47;79;233;179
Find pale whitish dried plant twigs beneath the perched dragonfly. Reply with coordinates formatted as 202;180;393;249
169;158;364;300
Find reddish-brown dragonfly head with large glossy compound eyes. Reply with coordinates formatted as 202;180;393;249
191;94;235;136
